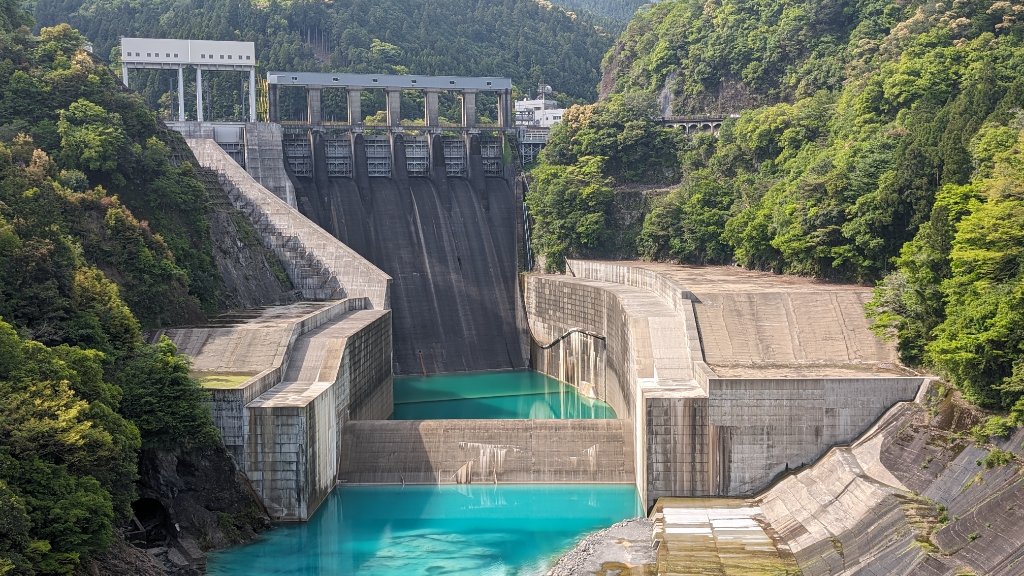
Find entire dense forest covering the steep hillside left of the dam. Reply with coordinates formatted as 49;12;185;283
0;0;231;575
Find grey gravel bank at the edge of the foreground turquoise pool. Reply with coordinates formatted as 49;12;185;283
548;518;657;576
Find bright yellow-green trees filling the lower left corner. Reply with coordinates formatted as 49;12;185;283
0;321;139;574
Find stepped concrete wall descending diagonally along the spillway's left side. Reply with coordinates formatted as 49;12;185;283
185;138;391;310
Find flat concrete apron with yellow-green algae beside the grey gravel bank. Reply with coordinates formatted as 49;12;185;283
650;498;801;576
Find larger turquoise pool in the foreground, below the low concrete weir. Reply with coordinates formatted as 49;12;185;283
208;484;641;576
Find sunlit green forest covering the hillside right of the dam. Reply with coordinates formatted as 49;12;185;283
527;0;1024;413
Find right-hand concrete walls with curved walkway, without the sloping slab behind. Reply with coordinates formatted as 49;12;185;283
525;260;924;504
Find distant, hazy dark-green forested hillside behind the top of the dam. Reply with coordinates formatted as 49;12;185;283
35;0;611;99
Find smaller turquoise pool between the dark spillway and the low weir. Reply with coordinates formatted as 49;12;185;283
394;370;615;420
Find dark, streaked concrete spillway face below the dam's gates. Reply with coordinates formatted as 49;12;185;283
292;132;526;374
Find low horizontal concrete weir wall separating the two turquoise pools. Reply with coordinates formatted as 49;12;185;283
338;420;634;484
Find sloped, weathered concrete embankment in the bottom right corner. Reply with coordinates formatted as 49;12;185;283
757;389;1024;576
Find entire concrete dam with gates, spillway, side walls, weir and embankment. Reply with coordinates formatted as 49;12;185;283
123;39;1024;576
